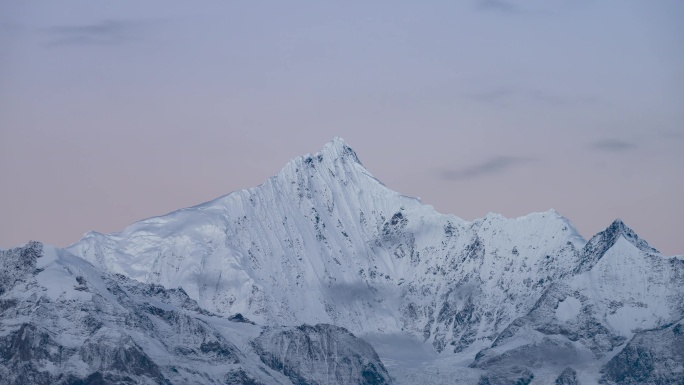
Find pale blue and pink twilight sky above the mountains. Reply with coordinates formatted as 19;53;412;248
0;0;684;255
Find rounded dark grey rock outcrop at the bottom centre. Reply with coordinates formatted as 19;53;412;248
254;324;391;385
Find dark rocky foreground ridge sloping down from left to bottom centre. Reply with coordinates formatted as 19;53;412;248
0;242;391;385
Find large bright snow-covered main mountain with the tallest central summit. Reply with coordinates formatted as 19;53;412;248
69;138;585;351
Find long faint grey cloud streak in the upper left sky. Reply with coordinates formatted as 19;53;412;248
45;20;144;46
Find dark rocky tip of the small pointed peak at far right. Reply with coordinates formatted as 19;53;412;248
577;218;660;272
